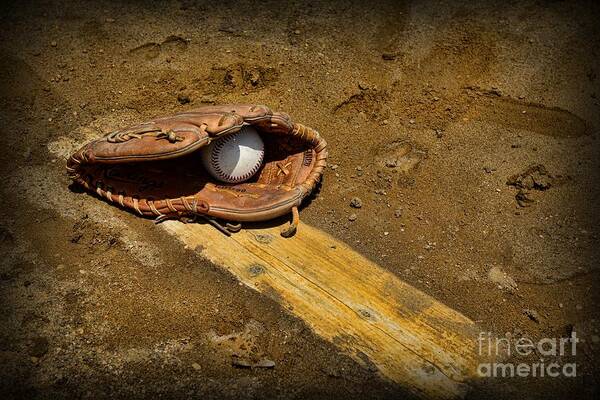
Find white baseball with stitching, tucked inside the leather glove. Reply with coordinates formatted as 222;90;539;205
201;125;265;183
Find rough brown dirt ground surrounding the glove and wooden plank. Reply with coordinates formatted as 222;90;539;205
0;0;600;399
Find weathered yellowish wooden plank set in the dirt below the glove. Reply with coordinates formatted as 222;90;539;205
163;221;486;398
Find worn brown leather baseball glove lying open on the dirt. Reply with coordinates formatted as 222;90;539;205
67;104;327;237
